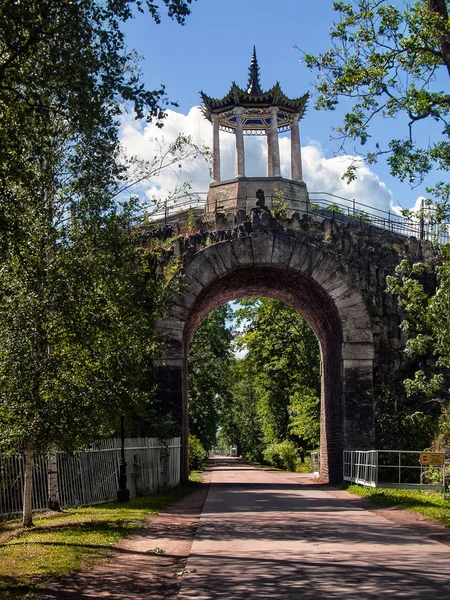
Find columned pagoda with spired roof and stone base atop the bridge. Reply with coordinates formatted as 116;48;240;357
200;47;308;214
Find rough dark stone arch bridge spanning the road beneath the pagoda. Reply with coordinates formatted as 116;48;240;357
147;208;432;482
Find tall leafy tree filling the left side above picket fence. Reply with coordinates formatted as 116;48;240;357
0;0;191;525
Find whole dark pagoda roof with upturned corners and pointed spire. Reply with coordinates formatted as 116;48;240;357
200;47;309;133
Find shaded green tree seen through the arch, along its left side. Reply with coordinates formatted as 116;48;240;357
189;304;234;450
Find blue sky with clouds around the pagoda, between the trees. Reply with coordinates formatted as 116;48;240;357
123;0;446;213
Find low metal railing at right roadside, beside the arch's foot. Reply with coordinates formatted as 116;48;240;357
344;450;450;493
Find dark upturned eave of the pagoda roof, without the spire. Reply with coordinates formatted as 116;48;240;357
200;83;308;120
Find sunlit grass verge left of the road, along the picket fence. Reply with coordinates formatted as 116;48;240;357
0;479;198;600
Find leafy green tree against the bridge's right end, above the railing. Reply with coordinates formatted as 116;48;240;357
387;250;450;447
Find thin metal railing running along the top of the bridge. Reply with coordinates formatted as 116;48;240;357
141;192;450;244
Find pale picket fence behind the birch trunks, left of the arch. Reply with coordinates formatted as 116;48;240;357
0;438;181;518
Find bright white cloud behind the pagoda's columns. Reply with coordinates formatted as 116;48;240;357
121;107;392;216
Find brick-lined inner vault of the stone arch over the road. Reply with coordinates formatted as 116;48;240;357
183;266;344;480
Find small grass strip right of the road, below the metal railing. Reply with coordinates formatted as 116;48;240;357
347;485;450;527
